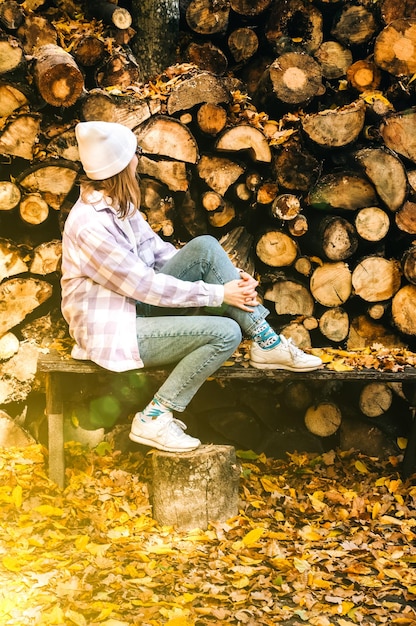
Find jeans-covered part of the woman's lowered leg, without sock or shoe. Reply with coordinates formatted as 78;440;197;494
137;315;241;411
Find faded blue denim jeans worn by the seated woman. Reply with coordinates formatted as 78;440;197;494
136;235;269;411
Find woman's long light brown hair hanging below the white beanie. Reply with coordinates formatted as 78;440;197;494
80;165;140;219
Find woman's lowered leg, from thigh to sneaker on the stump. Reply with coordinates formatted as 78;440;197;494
129;315;241;452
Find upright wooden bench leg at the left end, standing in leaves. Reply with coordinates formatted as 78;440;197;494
46;372;65;488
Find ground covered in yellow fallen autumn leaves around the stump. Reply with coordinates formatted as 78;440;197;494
0;444;416;626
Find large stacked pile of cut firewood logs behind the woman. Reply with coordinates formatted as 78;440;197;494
0;0;416;454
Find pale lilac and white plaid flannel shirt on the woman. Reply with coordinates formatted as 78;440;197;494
61;192;224;372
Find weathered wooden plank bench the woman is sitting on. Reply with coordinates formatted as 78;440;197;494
38;351;416;487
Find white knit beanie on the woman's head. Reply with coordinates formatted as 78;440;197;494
75;122;137;180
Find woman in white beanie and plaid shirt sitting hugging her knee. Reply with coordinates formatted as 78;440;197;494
62;122;322;452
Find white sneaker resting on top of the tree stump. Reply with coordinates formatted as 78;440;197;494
129;411;201;452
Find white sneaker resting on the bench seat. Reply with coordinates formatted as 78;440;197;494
250;335;322;372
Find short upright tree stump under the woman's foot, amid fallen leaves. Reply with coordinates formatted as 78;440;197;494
152;445;240;530
